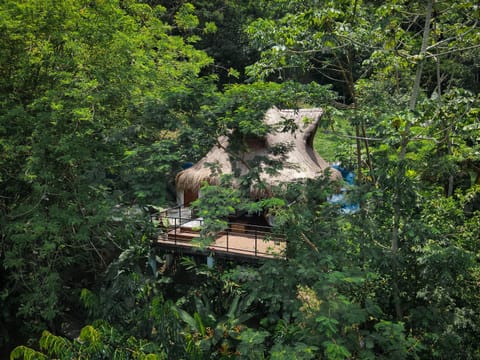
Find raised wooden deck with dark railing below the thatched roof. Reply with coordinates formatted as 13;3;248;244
157;207;286;259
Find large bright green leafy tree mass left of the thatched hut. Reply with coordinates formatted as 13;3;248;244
0;0;214;346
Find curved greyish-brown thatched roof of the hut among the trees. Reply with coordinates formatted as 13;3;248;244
176;108;341;197
